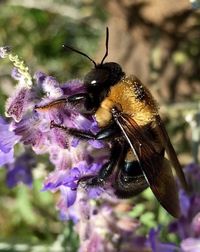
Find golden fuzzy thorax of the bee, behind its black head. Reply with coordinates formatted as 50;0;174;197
95;75;158;127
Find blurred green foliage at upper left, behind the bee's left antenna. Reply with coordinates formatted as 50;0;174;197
0;1;106;109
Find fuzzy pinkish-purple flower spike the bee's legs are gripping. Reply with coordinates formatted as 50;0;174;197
2;69;109;218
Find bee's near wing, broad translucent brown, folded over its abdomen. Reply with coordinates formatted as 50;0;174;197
113;111;180;218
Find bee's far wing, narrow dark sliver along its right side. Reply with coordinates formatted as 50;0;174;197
156;115;188;191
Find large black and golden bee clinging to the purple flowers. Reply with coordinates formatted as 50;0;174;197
36;28;187;218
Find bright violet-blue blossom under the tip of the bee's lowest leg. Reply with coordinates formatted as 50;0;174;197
43;157;107;219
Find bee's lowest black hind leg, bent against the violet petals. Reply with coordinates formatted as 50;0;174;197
79;141;122;186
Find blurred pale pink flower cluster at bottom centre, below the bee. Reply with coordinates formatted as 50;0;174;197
69;190;150;252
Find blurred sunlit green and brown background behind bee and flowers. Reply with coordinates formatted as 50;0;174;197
0;0;200;252
